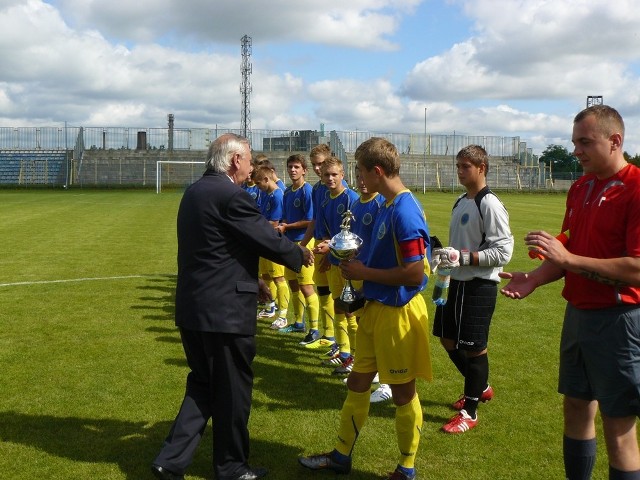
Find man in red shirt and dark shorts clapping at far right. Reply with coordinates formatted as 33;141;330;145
500;105;640;480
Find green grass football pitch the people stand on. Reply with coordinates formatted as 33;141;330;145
0;191;607;480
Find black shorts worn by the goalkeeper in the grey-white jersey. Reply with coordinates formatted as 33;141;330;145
433;278;498;351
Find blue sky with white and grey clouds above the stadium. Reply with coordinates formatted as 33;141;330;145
0;0;640;155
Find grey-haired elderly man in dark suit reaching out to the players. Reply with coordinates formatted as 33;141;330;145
151;134;313;480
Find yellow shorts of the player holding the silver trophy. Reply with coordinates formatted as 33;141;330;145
353;294;433;384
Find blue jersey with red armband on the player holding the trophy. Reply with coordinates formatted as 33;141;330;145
363;190;429;307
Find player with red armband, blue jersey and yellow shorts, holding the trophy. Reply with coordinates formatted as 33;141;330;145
298;137;432;480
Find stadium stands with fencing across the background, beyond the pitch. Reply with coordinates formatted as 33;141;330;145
0;125;571;191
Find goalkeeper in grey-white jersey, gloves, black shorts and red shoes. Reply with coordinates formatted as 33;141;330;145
432;145;513;433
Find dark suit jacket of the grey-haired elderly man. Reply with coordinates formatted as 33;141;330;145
176;172;303;335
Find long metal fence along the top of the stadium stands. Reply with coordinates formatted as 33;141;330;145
0;124;537;158
